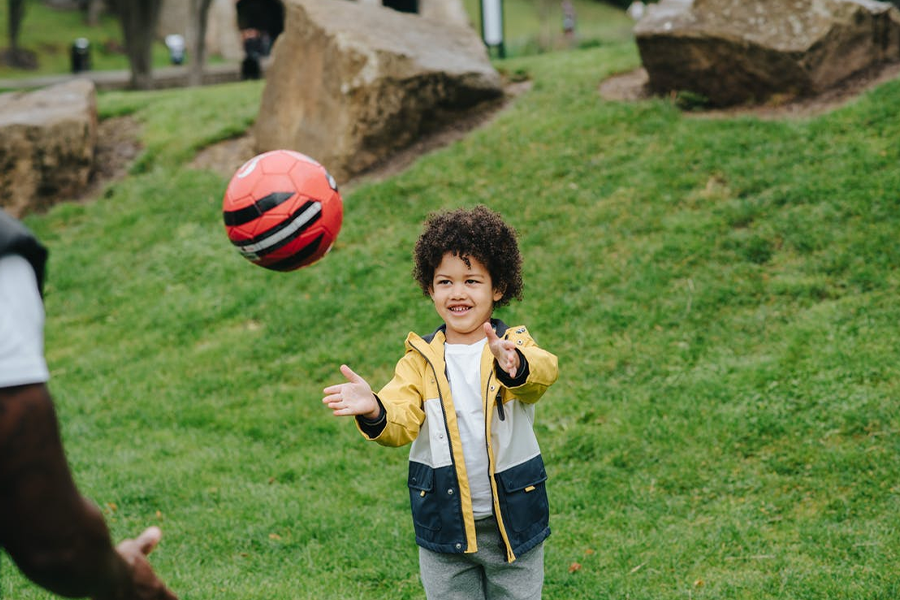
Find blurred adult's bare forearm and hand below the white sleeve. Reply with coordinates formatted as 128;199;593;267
0;384;174;599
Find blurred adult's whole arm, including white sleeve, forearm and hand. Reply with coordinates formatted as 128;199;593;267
0;257;174;600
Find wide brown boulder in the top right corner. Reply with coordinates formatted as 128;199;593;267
634;0;900;106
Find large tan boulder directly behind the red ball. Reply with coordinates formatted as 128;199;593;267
254;0;503;181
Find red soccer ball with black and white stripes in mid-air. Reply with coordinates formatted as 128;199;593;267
222;150;344;271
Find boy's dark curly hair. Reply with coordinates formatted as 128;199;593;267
413;205;524;307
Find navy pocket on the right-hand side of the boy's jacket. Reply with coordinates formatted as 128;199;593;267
495;455;550;532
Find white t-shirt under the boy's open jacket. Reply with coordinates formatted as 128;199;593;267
444;338;494;519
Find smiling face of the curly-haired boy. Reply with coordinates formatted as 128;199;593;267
430;252;503;344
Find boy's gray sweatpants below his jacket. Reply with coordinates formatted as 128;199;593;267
419;517;544;600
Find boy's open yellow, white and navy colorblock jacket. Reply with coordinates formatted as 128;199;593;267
357;319;558;562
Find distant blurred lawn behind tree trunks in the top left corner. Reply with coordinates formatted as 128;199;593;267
0;0;177;79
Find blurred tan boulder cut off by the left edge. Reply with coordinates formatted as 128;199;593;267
0;79;97;216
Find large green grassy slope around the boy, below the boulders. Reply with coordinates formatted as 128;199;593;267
0;30;900;600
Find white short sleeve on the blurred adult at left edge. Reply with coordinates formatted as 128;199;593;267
0;254;50;387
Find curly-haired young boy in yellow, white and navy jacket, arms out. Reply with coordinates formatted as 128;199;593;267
322;206;557;600
